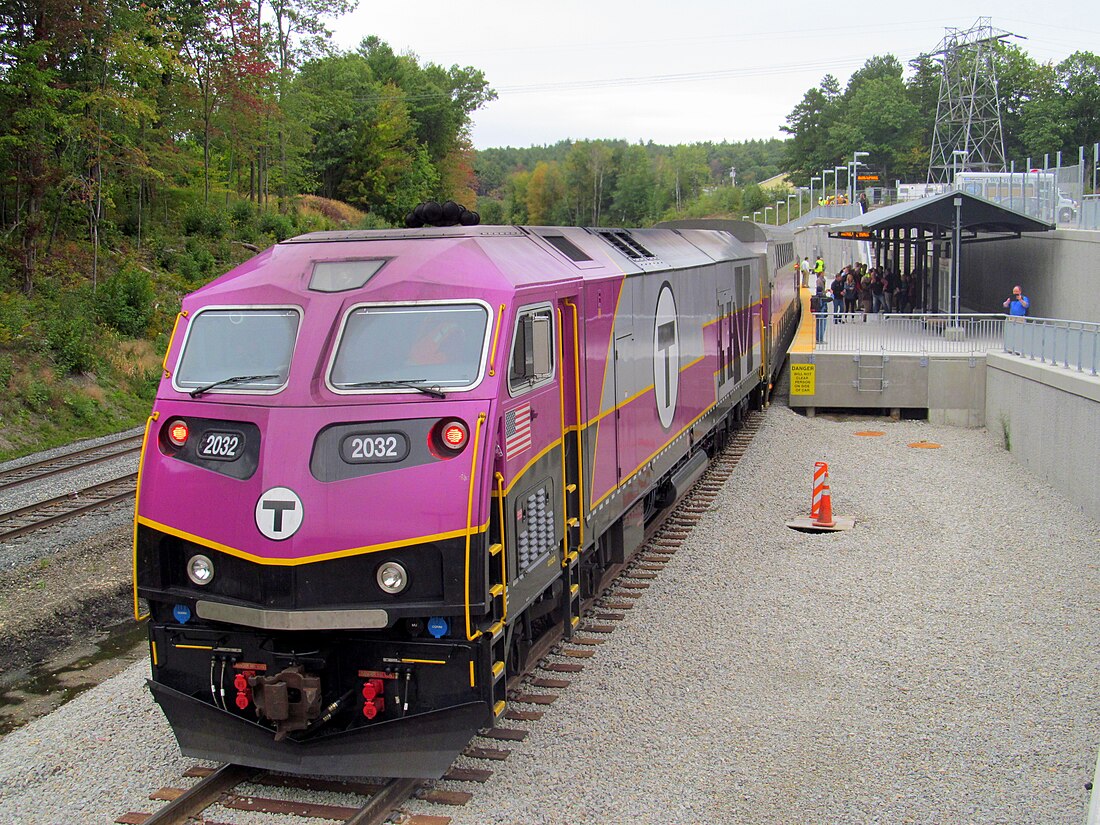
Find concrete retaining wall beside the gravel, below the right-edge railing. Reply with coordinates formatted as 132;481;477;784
985;352;1100;519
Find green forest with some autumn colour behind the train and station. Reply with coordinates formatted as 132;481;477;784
0;0;1100;459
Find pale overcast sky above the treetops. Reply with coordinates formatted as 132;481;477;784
323;0;1100;149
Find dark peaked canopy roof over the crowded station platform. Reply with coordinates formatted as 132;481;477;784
828;190;1055;243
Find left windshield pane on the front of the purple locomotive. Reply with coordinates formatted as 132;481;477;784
174;308;299;393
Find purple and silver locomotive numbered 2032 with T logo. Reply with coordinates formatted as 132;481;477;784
134;217;799;778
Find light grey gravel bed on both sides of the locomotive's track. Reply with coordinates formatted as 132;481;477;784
0;407;1100;825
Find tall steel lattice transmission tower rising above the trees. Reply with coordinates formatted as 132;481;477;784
928;18;1014;184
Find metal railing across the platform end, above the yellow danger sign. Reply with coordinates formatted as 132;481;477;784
814;311;1005;355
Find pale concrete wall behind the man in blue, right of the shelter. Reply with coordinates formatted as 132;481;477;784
961;229;1100;322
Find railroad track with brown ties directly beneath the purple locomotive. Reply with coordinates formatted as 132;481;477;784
116;411;765;825
